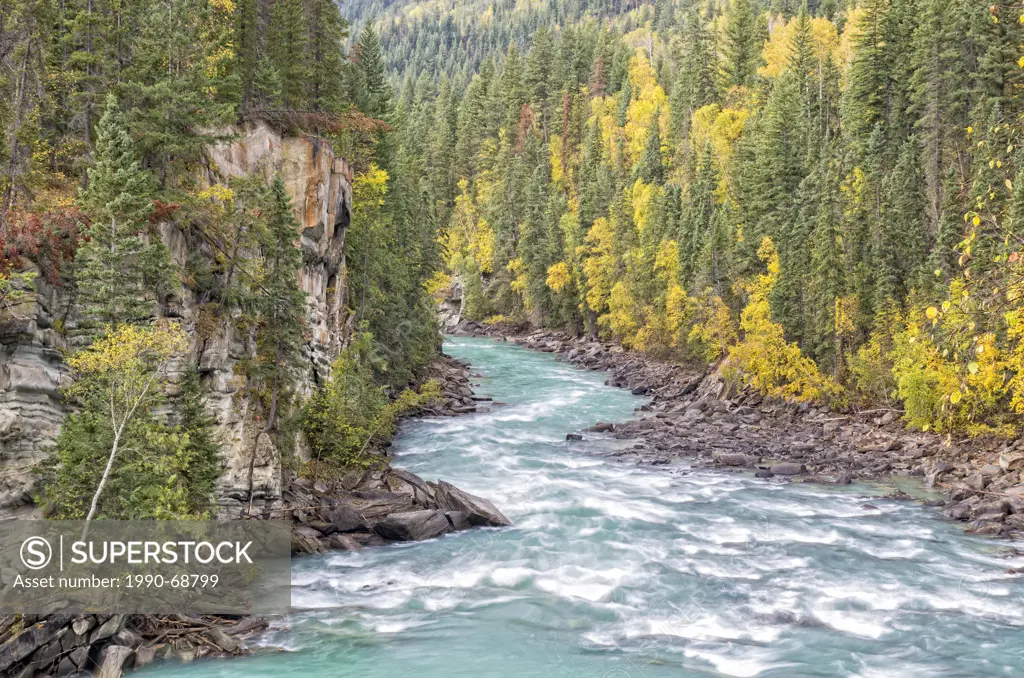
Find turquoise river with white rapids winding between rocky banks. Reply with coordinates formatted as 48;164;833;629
132;338;1024;678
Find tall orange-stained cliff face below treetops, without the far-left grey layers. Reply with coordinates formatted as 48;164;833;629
190;124;352;517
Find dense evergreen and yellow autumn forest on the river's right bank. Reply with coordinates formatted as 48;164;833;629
346;0;1024;434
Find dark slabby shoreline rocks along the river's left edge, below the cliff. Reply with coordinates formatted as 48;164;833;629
0;355;512;678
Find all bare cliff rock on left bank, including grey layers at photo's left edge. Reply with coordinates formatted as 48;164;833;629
0;124;352;518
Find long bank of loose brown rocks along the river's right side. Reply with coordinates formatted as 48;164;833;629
455;323;1024;539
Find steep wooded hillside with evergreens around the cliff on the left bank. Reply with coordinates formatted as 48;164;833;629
0;0;439;518
